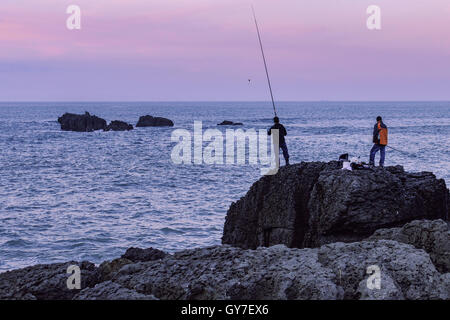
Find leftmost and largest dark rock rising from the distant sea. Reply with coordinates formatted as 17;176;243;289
58;112;106;132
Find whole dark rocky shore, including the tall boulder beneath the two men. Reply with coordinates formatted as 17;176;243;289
0;162;450;300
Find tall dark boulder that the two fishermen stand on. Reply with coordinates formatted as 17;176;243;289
222;161;449;249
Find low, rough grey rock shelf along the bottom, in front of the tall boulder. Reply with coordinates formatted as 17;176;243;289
0;240;450;300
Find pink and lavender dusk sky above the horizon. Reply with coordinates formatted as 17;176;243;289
0;0;450;101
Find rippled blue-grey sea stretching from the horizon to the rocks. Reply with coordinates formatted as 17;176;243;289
0;102;450;271
